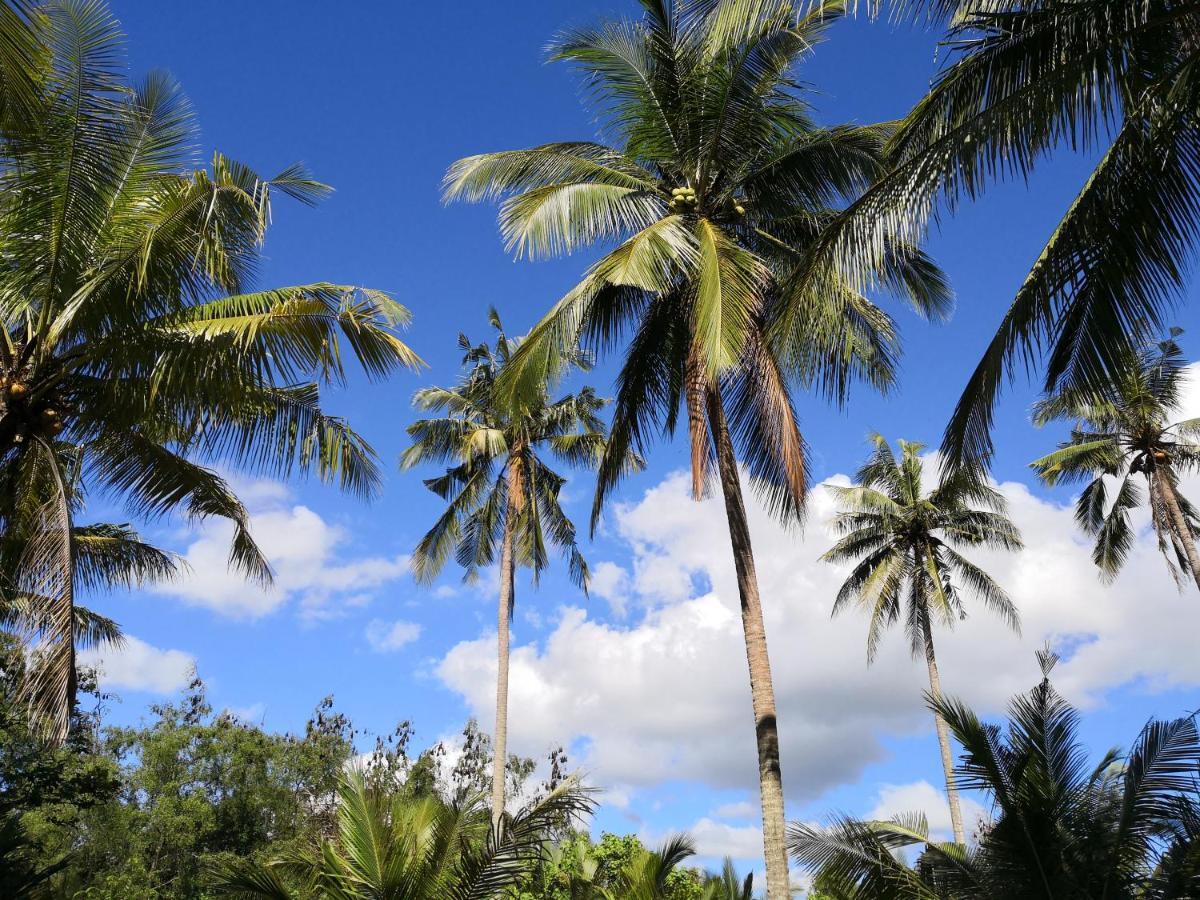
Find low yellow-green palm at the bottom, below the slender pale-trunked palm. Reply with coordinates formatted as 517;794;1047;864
212;774;592;900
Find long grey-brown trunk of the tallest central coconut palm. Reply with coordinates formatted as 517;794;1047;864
708;385;792;900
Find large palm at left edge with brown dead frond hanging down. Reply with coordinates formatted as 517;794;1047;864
0;0;419;739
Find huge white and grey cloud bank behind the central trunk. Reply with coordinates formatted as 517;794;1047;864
438;473;1200;802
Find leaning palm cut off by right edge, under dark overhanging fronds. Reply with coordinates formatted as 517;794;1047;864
1031;329;1200;587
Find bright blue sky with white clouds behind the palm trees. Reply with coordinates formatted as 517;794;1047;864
79;0;1200;883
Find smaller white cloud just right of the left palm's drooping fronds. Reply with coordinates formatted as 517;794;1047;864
156;481;409;619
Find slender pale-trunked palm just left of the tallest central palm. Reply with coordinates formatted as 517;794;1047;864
401;310;605;822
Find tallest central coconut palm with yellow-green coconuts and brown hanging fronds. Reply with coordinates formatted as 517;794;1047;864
445;0;950;900
